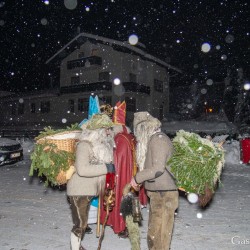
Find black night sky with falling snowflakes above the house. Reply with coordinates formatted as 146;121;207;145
0;0;250;91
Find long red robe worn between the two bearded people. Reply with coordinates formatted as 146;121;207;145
100;126;146;234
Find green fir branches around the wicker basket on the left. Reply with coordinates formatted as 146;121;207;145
29;124;81;186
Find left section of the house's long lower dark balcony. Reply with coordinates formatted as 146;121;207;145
60;82;112;94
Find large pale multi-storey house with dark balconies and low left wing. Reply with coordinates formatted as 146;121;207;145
0;33;181;131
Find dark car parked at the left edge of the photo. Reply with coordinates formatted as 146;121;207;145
0;137;23;166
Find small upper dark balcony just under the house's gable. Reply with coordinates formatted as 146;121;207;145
67;56;102;69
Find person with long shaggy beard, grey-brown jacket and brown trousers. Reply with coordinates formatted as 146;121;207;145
130;112;179;250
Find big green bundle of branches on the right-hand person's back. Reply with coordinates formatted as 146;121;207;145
168;130;225;206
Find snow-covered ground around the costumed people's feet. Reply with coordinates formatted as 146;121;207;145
0;141;250;250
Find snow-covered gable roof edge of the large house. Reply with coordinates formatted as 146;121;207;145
46;32;182;73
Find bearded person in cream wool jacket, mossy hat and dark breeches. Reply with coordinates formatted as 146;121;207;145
67;114;115;250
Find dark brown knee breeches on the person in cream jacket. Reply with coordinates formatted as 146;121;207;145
69;196;93;239
